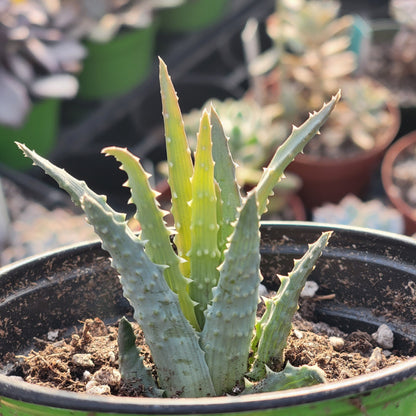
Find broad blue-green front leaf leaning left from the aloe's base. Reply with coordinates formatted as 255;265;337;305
82;195;215;397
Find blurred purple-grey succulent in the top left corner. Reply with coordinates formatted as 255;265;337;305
0;0;86;127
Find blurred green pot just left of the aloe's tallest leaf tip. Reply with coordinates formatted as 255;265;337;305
78;22;157;100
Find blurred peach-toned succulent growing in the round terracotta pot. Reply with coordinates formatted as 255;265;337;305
254;0;391;157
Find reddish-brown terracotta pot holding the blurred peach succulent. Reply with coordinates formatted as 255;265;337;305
288;105;400;209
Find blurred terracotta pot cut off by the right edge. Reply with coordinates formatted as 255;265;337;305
381;131;416;235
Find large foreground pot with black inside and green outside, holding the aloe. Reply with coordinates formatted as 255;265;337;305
0;222;416;416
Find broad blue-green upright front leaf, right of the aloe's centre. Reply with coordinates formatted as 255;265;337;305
201;193;261;394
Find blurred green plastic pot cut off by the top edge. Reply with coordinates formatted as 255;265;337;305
160;0;229;33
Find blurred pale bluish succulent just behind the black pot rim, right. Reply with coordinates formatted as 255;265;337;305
313;195;404;234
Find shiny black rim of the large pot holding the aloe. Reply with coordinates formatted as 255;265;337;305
0;221;416;415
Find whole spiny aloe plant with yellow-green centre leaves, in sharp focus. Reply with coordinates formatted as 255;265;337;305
18;60;339;397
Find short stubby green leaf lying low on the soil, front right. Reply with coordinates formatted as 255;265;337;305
243;363;326;394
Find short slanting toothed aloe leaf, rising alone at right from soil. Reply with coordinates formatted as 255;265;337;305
249;232;331;380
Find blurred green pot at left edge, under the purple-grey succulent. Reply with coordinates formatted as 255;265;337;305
0;99;61;170
